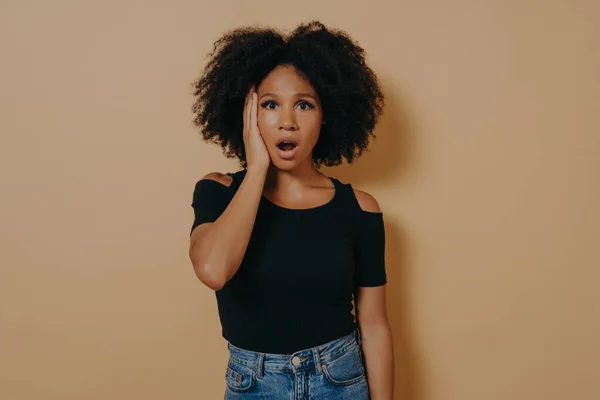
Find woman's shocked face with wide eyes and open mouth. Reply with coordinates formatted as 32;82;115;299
257;65;323;170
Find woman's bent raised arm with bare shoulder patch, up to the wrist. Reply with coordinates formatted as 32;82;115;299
189;169;266;290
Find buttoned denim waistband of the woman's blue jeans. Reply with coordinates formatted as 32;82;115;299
227;328;361;378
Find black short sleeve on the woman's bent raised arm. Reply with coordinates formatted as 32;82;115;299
190;179;231;236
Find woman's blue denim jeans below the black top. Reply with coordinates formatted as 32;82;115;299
224;329;370;400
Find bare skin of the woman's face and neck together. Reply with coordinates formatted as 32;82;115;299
257;66;335;209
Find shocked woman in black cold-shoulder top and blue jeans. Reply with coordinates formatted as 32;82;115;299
189;22;393;400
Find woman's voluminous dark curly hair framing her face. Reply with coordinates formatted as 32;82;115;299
192;21;384;168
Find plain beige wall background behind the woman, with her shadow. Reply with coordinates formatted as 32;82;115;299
0;0;600;400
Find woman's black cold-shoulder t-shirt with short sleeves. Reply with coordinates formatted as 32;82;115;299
192;169;386;354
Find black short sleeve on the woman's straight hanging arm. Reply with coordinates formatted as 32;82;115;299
354;210;387;287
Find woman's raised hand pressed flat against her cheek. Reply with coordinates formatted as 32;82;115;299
243;85;271;171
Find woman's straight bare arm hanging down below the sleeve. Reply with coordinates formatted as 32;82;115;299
356;285;394;400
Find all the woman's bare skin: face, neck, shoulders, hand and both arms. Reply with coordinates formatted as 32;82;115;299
190;66;394;400
